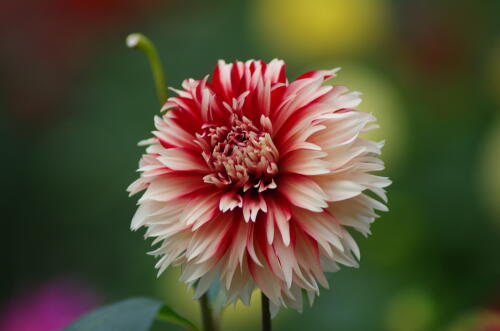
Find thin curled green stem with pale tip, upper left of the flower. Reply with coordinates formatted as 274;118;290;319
127;33;167;105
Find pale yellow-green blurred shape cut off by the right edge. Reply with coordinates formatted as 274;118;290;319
479;117;500;228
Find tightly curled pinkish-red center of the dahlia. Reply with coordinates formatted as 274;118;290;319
197;115;279;192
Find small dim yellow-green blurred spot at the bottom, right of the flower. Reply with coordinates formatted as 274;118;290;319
386;288;436;331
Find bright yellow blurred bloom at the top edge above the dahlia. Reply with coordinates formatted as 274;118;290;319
250;0;390;58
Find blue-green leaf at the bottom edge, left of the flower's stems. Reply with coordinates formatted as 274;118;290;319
63;298;198;331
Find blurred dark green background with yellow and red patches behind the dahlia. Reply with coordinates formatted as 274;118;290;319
0;0;500;331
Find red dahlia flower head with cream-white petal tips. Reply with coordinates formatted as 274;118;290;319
128;60;390;311
